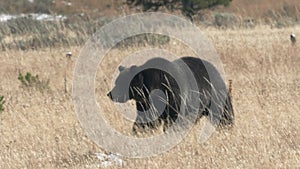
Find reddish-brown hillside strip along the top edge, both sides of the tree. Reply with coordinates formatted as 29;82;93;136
0;0;300;20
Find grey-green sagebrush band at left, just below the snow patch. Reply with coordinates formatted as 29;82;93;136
0;15;109;50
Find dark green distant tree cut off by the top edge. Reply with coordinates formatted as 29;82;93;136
127;0;232;19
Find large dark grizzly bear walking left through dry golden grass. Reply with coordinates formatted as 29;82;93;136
107;57;234;133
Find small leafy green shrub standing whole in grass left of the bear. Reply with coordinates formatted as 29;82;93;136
18;72;50;91
